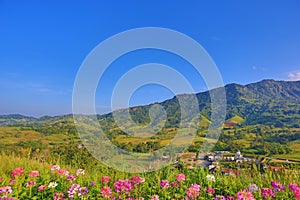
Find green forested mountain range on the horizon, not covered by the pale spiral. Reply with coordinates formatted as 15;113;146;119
0;80;300;128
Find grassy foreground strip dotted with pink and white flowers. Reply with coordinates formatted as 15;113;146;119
0;155;300;200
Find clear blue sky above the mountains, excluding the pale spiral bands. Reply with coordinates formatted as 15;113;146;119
0;0;300;116
